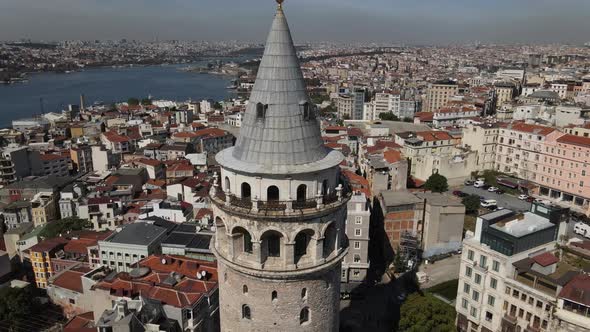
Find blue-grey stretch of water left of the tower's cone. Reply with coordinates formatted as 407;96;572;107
0;61;233;127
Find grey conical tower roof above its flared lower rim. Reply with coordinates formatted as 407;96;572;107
233;6;329;169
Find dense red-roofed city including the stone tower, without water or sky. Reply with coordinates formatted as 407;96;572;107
0;0;590;332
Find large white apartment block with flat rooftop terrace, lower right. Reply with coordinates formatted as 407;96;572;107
455;203;573;332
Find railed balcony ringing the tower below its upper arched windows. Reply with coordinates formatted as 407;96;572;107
210;185;352;218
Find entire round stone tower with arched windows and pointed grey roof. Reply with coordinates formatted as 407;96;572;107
211;0;350;332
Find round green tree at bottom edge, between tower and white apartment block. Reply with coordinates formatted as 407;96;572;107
398;293;457;332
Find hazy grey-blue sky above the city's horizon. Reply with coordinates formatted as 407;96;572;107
0;0;590;44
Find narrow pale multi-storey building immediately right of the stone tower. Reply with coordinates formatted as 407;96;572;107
340;192;371;284
